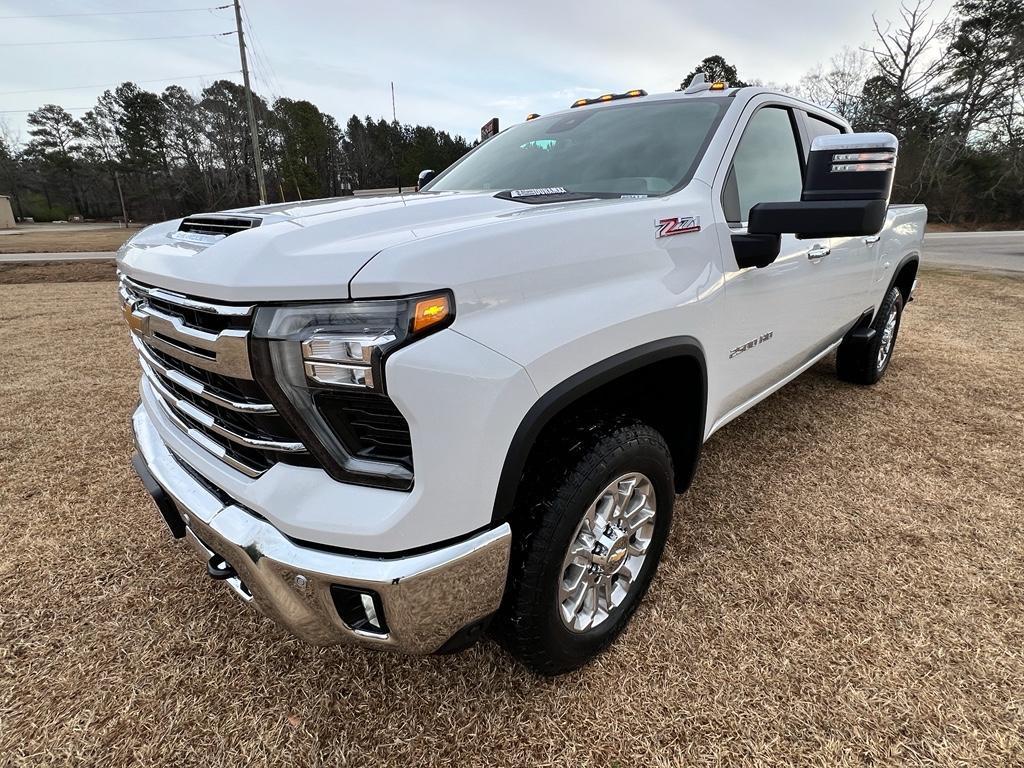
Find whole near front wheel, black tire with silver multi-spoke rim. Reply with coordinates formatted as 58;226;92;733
493;418;675;675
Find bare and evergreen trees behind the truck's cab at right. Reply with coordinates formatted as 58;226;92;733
694;0;1024;225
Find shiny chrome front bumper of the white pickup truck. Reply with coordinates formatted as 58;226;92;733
132;407;511;653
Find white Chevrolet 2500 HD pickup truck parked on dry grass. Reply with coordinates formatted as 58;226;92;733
118;78;926;674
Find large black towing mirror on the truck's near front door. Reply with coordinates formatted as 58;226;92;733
746;133;899;238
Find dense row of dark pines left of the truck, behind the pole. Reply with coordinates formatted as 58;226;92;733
0;80;470;221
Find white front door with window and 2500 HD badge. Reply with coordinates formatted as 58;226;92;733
710;96;838;423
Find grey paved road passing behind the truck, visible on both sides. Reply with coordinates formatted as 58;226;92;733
6;231;1024;272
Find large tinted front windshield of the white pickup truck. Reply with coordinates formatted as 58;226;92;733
425;98;728;196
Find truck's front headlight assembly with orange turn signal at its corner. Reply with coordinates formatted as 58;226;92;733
252;291;455;488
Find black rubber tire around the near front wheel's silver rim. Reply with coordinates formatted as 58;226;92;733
490;417;675;675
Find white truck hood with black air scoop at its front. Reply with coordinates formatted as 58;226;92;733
117;193;524;302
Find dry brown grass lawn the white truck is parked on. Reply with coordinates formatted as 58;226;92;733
0;272;1024;768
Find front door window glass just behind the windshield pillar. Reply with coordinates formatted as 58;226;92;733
722;106;804;224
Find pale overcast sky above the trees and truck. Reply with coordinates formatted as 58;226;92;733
0;0;952;140
